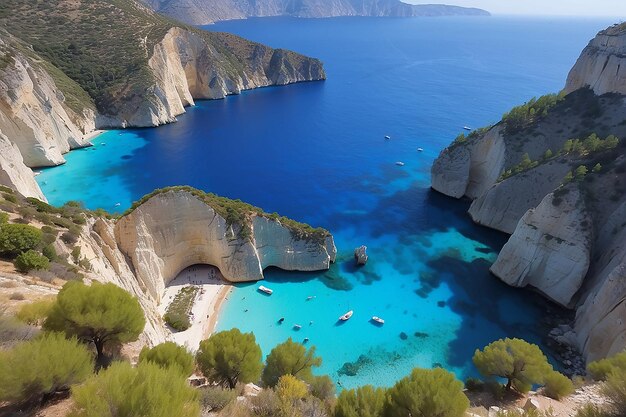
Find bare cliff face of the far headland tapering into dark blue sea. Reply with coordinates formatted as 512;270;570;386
106;27;326;127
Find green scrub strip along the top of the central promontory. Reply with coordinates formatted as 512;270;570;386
122;186;330;244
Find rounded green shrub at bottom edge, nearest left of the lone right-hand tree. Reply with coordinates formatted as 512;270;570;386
384;368;469;417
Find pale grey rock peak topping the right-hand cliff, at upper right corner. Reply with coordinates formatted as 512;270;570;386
565;24;626;95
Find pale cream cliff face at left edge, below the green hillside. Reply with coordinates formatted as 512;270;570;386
0;36;94;167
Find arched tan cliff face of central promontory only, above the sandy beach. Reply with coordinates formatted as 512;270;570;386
115;191;336;300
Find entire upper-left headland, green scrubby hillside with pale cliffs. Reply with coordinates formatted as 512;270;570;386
0;0;325;197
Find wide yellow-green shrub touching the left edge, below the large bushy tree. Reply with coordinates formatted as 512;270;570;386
0;333;93;403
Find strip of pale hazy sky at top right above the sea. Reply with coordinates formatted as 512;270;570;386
412;0;626;18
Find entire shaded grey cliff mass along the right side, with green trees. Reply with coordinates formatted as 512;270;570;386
432;25;626;360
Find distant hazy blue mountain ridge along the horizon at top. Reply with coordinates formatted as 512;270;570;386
143;0;489;25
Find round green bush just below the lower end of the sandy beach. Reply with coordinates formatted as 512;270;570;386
196;329;263;389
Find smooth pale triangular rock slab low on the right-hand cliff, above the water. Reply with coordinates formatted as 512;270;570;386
490;186;593;306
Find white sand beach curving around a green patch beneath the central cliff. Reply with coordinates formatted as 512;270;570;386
159;265;231;352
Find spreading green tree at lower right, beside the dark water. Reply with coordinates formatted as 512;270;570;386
473;338;552;392
